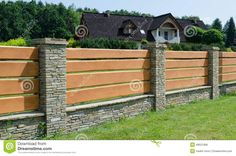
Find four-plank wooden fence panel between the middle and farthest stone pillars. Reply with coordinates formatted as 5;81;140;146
166;51;208;90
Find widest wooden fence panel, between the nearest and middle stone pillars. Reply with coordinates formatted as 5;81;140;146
67;49;150;105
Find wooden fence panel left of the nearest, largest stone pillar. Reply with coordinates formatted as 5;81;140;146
0;47;39;114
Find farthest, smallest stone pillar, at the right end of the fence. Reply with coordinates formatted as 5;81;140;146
208;47;220;99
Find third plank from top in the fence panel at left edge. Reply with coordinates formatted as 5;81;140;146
0;79;39;95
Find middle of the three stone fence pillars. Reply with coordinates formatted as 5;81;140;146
149;43;166;110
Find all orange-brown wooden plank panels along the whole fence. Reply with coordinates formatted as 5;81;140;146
0;47;236;114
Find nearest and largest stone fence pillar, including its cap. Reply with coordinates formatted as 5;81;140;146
32;38;67;136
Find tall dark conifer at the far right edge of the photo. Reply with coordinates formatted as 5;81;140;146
225;17;236;47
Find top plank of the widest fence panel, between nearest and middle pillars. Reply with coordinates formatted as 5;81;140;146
66;48;150;59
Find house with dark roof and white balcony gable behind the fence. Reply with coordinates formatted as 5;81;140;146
78;13;206;43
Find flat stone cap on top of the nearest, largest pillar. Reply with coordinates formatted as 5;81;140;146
32;38;68;45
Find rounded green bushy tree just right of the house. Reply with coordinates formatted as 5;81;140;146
202;29;224;44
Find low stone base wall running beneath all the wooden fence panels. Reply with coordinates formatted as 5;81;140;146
0;82;236;140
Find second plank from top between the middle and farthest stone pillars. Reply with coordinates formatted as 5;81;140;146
166;59;208;69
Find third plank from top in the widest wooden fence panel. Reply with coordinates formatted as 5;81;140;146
67;70;150;88
